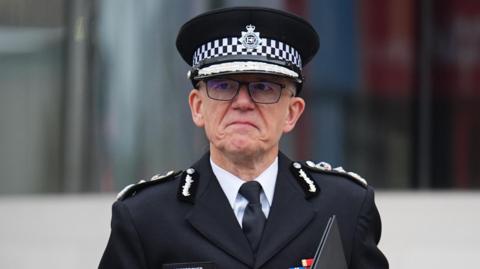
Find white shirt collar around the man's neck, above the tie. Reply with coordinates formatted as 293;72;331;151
210;157;278;208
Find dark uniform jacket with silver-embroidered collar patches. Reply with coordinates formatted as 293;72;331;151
99;153;388;269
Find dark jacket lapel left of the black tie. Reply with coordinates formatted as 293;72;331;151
186;154;254;267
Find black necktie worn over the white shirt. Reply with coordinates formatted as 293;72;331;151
238;181;266;253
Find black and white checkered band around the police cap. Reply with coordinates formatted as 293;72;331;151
193;37;302;70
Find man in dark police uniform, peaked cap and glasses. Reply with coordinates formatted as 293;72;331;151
100;8;388;269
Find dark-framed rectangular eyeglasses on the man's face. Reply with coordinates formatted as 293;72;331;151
206;78;293;104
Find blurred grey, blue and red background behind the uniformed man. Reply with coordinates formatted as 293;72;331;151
0;0;480;268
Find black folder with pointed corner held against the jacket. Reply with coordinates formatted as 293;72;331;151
311;215;348;269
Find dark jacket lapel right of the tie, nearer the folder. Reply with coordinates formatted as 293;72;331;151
254;153;315;268
